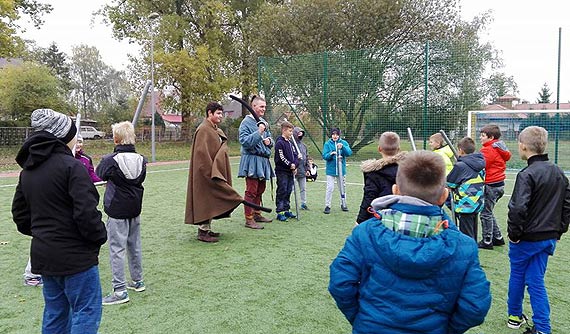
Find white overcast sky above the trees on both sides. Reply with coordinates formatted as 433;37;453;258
16;0;570;102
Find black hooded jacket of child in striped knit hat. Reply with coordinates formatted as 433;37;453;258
12;131;107;276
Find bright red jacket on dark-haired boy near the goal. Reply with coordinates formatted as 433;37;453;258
481;139;511;184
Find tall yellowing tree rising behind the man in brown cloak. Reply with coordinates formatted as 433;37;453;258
101;0;278;122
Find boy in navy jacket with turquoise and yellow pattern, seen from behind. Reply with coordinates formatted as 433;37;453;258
447;137;485;241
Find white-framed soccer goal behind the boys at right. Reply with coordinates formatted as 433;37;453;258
467;109;570;171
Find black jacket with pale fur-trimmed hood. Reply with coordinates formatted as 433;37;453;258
356;152;406;224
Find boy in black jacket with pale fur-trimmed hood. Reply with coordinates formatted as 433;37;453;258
356;131;405;224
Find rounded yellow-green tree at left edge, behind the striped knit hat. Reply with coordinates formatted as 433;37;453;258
0;62;71;123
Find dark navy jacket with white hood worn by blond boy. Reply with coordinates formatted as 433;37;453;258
96;145;147;219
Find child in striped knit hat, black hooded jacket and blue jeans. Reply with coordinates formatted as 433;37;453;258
12;109;107;334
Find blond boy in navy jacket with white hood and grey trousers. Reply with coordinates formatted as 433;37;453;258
97;122;147;305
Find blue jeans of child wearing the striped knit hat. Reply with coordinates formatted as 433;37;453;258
42;266;103;334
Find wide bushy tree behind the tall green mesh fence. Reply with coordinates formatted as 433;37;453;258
250;0;494;151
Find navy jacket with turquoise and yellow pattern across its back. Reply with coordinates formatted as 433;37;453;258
447;153;485;213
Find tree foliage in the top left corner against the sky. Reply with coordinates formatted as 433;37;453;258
0;0;52;57
